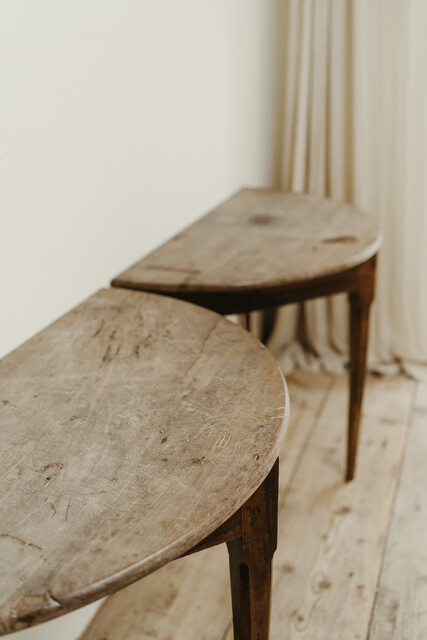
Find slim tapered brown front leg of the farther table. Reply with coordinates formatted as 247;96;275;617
346;259;375;482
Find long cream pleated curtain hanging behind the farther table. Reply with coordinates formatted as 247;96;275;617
270;0;427;375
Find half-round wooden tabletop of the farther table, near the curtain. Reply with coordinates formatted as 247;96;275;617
113;189;381;294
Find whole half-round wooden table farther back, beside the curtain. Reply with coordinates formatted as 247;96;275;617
112;189;381;480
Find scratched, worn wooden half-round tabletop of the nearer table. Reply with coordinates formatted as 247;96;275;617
0;289;288;634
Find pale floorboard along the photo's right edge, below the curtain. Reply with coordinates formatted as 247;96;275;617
369;383;427;640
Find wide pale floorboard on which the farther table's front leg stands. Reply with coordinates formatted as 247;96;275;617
268;378;413;640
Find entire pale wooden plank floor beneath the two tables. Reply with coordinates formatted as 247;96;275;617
82;373;427;640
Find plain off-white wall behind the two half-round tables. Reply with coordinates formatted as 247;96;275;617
0;0;281;640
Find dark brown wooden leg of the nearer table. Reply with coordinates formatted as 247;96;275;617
227;461;278;640
